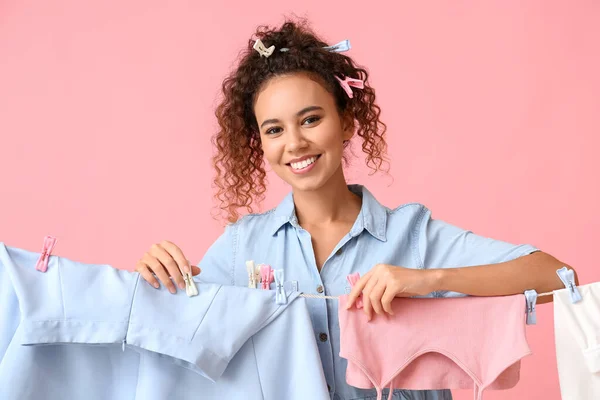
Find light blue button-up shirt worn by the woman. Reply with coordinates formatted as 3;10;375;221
198;185;537;400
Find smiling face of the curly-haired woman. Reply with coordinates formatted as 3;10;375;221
254;73;354;191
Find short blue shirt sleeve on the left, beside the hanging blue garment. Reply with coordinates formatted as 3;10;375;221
198;225;238;285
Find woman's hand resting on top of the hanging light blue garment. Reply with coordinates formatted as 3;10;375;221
135;240;200;293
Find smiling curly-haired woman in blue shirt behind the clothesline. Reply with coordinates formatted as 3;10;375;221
136;18;576;400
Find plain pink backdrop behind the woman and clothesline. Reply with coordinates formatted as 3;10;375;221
0;0;600;400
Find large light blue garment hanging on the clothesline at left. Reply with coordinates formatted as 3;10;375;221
0;243;330;400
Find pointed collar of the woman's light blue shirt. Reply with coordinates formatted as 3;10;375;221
270;185;388;242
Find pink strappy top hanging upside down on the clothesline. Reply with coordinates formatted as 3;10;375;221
339;295;531;400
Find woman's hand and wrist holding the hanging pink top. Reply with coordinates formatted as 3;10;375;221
346;264;439;321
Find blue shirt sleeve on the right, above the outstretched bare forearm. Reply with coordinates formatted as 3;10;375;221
417;209;539;297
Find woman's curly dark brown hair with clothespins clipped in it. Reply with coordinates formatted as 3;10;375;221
212;20;389;222
